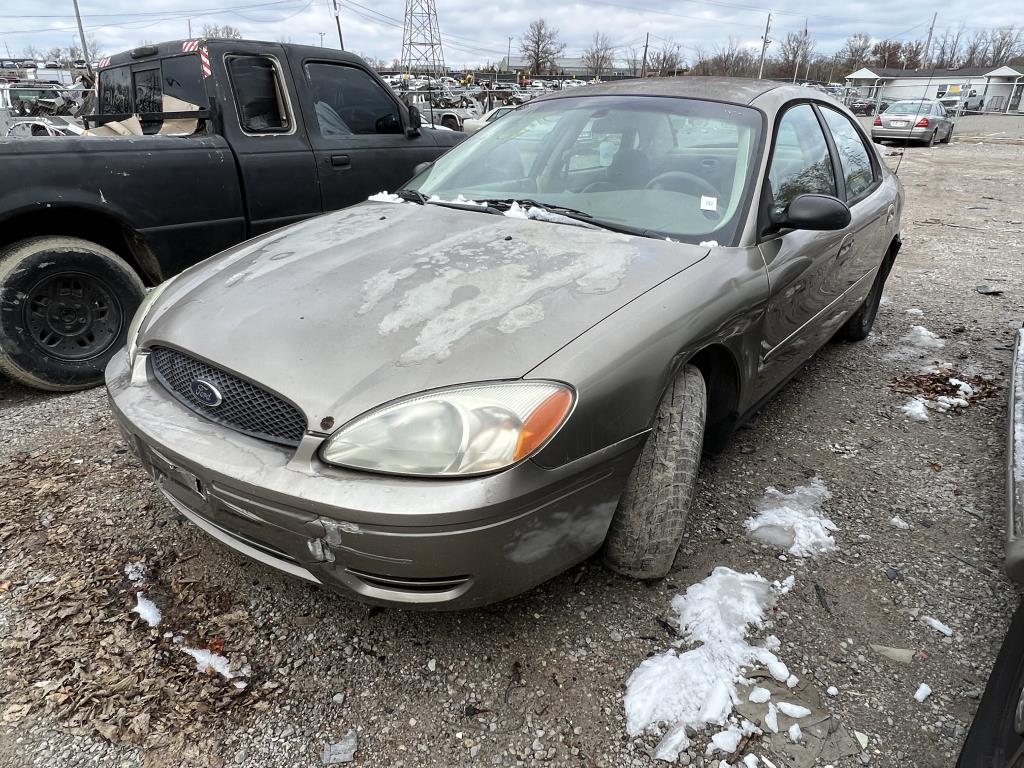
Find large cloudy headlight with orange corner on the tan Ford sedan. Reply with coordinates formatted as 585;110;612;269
321;381;574;477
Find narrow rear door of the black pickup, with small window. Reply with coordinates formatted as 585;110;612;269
223;53;322;237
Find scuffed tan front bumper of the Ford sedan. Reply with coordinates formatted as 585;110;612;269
106;353;643;609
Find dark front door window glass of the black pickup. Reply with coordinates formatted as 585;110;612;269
305;62;402;138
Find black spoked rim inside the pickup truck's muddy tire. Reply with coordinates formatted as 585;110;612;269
25;272;124;361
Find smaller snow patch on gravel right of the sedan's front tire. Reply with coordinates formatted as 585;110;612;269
744;477;839;557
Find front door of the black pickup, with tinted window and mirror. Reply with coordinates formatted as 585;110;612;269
293;58;437;211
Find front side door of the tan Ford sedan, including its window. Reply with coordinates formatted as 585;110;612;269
755;102;853;399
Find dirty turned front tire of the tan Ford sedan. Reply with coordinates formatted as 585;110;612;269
602;366;708;579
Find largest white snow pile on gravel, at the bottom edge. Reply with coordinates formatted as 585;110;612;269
625;566;794;762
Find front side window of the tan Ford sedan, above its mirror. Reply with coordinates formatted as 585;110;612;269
768;104;836;213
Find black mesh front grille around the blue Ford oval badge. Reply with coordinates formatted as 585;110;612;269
150;347;306;445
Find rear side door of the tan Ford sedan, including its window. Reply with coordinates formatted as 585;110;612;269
818;104;888;303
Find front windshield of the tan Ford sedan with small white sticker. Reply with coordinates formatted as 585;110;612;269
408;95;762;245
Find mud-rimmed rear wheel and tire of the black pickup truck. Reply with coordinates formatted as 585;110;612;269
0;238;145;392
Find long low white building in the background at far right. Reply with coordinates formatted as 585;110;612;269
846;66;1024;113
